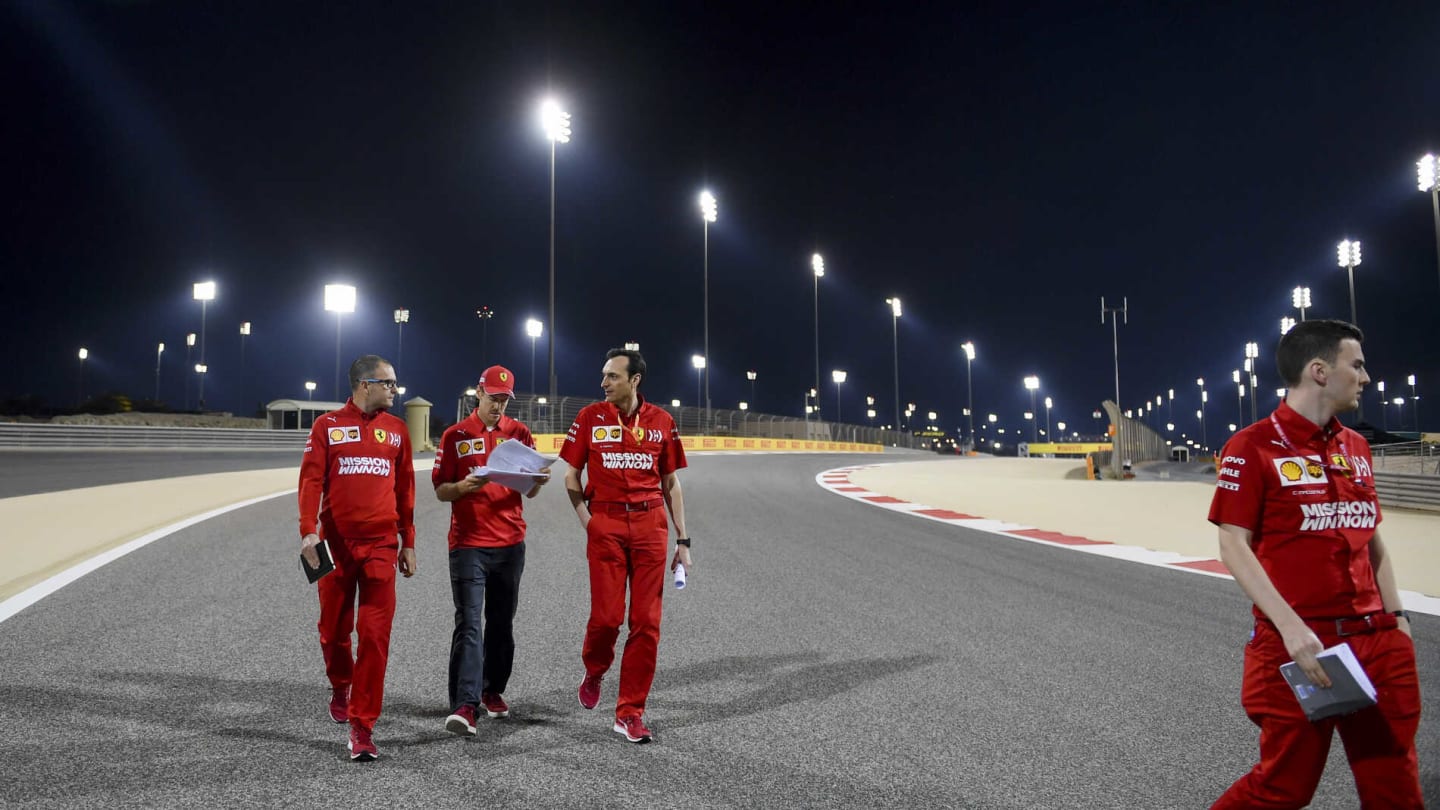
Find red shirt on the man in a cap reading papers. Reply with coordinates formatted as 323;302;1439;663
431;412;536;551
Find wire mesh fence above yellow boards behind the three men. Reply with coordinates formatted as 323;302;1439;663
455;392;920;448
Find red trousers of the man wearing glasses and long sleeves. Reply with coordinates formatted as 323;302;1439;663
318;535;400;729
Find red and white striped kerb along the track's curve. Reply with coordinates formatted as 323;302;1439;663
815;464;1440;615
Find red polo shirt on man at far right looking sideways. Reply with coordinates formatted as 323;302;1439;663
1210;402;1384;618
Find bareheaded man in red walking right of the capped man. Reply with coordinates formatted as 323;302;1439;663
560;343;691;742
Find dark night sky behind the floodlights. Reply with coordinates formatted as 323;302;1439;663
0;0;1440;441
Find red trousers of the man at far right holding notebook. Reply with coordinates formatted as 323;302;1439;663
1212;621;1424;810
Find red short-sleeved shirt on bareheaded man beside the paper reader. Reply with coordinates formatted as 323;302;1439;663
560;393;685;503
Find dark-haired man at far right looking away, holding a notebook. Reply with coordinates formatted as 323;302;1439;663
1210;320;1423;809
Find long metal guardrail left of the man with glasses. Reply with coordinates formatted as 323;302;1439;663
0;424;310;449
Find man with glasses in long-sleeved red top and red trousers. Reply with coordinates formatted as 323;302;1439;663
300;355;415;761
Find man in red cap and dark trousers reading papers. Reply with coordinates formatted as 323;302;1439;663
431;366;549;736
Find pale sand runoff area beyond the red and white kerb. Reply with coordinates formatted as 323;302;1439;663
850;455;1440;597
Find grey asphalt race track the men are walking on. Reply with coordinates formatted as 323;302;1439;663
0;454;1440;810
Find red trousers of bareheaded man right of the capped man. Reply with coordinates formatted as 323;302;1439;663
580;502;670;718
